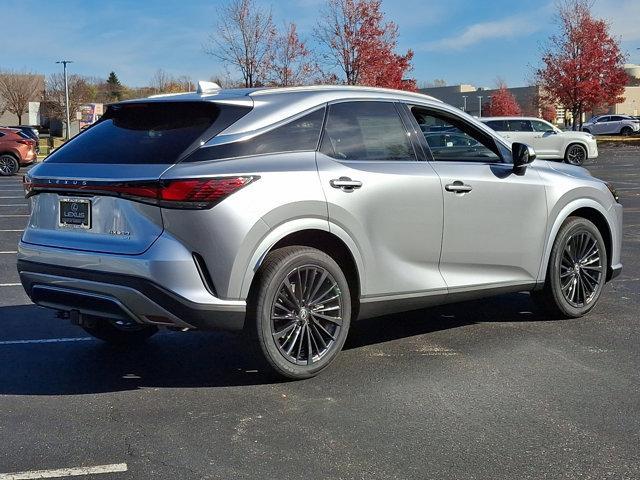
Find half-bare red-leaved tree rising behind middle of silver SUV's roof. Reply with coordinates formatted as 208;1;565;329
315;0;416;90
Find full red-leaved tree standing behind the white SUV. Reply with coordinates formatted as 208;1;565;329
537;0;627;130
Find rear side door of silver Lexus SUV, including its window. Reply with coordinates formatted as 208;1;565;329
317;101;446;298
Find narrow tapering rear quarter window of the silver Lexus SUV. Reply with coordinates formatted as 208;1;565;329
186;108;324;162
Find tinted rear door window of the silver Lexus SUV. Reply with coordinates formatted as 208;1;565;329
320;102;415;160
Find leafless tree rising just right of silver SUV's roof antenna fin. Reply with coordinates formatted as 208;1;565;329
204;0;276;87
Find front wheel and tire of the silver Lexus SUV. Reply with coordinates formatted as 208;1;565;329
532;217;608;318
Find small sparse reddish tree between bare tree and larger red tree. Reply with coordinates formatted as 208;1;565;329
268;22;316;87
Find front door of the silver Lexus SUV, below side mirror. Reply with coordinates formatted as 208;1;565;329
408;105;547;293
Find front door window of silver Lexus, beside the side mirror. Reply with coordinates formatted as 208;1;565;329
411;107;502;162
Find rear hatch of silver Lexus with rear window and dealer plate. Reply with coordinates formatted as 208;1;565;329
22;100;250;255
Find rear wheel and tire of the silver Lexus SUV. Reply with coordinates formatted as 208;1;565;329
245;246;351;379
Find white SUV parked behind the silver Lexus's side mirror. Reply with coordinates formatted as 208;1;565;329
481;117;598;165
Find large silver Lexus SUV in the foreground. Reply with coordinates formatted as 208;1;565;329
18;82;622;378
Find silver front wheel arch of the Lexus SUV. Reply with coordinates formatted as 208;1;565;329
538;199;613;283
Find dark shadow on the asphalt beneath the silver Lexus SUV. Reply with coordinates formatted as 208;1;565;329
0;294;545;395
